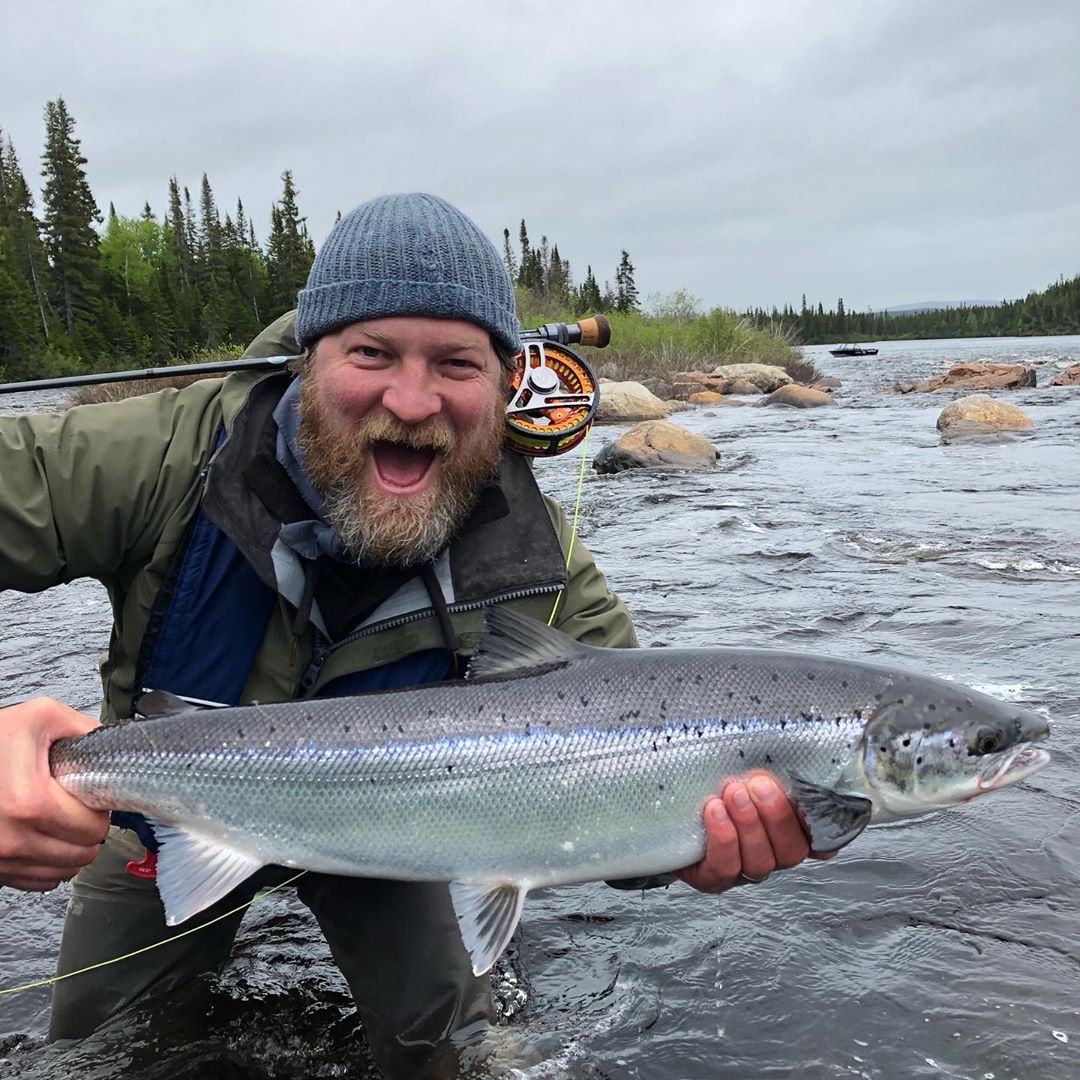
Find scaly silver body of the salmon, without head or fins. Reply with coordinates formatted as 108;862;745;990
56;650;883;883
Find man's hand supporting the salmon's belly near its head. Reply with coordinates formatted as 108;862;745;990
675;772;836;892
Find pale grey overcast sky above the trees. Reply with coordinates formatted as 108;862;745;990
0;0;1080;309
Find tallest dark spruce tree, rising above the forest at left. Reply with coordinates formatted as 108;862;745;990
42;97;104;349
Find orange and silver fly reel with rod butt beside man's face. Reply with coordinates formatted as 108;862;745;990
505;315;611;457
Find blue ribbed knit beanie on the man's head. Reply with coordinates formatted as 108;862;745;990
296;194;521;354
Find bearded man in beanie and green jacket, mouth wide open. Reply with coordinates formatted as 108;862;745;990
0;194;808;1078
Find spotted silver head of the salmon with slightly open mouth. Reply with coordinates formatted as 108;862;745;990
863;675;1050;818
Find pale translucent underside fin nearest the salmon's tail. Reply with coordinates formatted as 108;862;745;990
151;822;264;927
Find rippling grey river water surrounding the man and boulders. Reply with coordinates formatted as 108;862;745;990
0;337;1080;1080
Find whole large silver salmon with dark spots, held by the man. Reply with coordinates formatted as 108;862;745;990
51;608;1049;974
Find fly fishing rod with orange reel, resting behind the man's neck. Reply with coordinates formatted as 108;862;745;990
0;315;611;457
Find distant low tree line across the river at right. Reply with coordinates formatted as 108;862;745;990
744;275;1080;345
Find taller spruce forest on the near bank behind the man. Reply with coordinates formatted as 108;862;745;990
0;98;638;380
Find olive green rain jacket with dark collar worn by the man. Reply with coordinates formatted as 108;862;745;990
0;312;637;723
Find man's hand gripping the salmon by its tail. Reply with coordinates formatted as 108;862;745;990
0;698;109;892
